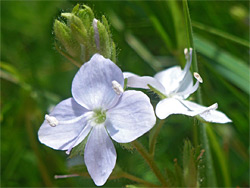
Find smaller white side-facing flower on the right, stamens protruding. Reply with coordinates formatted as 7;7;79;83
124;48;231;123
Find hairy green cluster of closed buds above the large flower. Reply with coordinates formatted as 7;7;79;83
54;4;116;65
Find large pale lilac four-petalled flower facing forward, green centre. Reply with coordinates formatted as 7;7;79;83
38;54;156;186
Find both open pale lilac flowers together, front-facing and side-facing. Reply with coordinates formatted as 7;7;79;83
38;49;231;186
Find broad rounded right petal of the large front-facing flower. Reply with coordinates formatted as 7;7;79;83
105;90;156;143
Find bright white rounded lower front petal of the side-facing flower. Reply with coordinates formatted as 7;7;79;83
155;98;206;119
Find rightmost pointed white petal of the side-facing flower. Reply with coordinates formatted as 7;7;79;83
180;101;232;123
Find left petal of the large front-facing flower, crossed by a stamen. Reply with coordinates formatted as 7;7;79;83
38;98;90;150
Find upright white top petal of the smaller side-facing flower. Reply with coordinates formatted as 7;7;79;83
154;66;193;98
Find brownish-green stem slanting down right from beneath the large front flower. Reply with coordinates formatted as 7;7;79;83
132;140;167;187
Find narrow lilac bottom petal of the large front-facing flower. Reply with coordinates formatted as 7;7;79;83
84;125;116;186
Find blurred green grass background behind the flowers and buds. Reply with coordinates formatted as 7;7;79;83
0;1;250;187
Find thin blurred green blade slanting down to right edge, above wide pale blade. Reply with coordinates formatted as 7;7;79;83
192;21;250;48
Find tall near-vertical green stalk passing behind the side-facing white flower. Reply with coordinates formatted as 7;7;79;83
183;0;217;187
